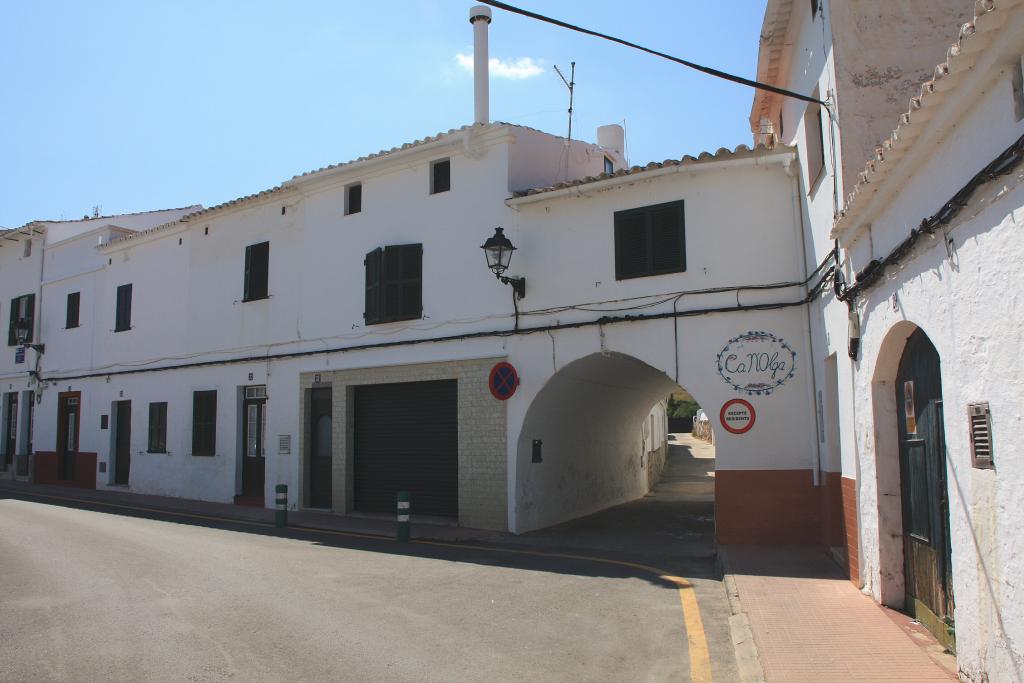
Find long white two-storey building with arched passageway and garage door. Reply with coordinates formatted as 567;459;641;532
4;6;821;542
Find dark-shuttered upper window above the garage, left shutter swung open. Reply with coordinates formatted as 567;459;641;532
362;245;423;325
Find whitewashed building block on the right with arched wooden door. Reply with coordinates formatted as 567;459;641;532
752;0;1024;681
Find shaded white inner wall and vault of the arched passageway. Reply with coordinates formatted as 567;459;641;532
515;352;714;532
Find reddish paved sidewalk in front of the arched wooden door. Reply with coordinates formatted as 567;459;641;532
723;546;956;683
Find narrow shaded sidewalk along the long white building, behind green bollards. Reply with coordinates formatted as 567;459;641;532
0;479;509;543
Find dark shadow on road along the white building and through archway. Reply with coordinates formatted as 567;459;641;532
0;435;720;590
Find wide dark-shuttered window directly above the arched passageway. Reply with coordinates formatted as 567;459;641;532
615;202;686;280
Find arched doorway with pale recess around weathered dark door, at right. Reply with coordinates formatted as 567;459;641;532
871;322;952;646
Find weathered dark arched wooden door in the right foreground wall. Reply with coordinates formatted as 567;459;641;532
896;330;953;647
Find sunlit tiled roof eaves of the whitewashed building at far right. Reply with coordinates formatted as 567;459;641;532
829;0;1021;239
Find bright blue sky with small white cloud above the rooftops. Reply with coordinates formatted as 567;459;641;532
0;0;765;227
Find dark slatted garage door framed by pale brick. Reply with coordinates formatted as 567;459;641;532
354;380;459;517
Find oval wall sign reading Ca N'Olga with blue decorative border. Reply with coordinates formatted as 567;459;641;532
718;331;797;396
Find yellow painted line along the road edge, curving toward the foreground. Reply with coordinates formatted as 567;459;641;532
8;489;712;683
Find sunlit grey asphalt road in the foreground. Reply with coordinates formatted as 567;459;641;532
0;440;734;681
